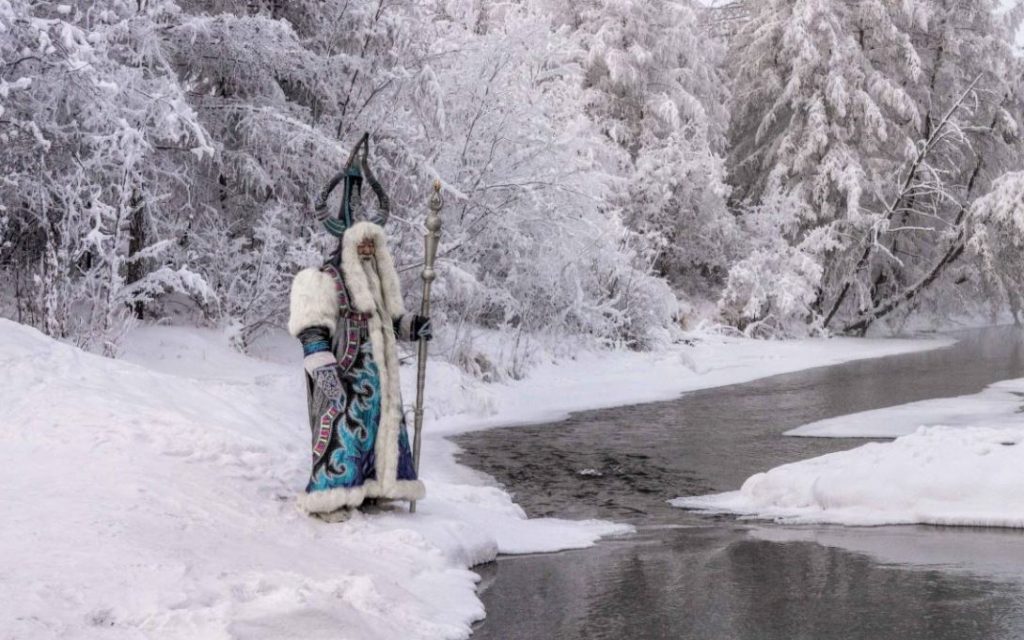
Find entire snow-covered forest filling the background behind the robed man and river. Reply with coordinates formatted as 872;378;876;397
0;0;1024;354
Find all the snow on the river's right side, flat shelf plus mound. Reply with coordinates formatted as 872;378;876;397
673;372;1024;527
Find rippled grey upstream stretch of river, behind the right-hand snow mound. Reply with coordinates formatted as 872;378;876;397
456;328;1024;524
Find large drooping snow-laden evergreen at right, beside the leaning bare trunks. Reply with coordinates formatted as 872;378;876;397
722;0;1020;333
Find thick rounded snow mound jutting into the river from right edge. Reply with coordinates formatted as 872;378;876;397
672;426;1024;528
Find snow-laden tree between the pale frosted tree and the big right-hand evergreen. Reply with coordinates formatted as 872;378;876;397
552;0;736;295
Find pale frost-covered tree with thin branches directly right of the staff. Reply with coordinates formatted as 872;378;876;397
387;6;676;359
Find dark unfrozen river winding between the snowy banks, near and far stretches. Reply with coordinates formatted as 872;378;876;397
457;328;1024;640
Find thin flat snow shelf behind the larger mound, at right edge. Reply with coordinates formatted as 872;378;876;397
785;378;1024;438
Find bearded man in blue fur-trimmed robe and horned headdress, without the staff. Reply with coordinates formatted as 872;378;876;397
288;136;431;514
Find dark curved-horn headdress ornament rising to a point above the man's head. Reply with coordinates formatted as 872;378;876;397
314;133;391;238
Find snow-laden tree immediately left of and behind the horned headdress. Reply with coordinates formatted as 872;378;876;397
150;0;400;346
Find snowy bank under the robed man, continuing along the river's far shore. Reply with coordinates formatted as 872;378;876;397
0;319;942;640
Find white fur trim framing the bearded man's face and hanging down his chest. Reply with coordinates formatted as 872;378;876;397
341;222;406;321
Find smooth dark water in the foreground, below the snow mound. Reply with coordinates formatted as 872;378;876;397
474;527;1024;640
